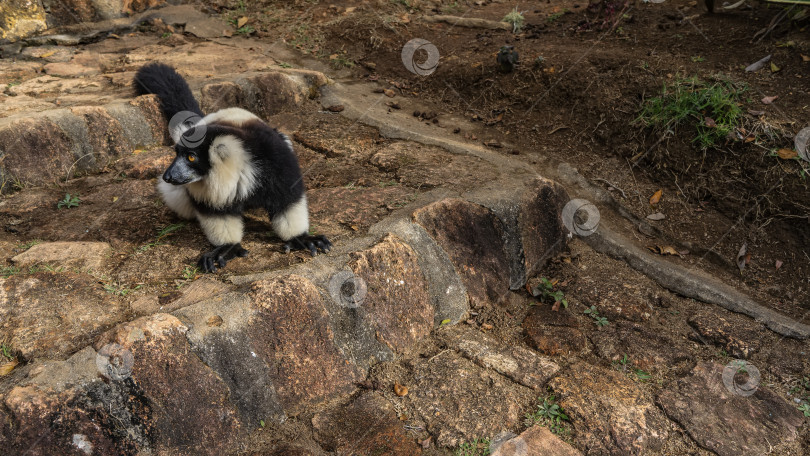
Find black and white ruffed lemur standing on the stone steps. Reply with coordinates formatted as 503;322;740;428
133;63;332;272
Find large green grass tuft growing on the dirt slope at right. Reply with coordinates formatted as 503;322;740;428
636;77;748;150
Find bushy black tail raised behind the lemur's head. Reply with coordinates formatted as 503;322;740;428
132;63;203;120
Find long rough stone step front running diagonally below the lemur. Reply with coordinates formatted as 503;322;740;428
0;175;567;454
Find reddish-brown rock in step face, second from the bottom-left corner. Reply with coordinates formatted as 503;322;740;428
96;314;242;455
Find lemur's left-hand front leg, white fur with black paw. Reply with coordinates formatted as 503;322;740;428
197;213;248;272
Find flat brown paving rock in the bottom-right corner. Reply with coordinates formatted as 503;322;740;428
658;362;806;456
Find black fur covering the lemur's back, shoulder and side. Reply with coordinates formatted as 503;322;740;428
183;120;305;218
